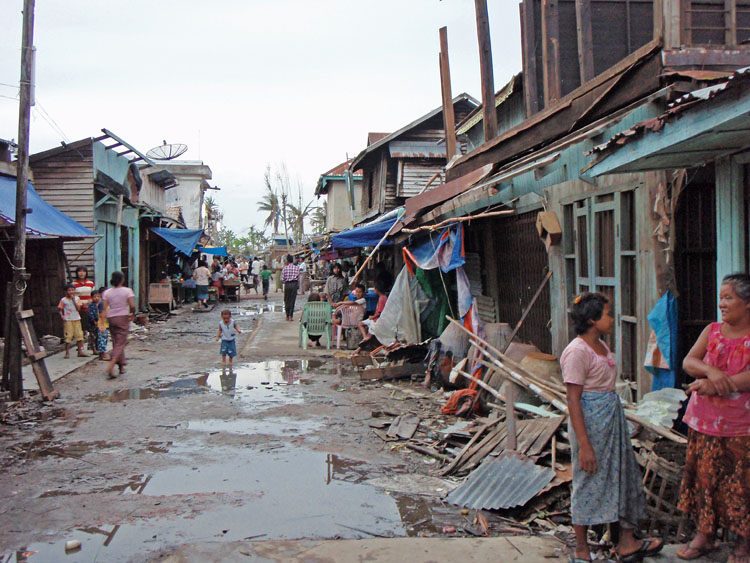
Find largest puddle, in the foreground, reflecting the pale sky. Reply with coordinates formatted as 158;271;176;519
3;447;455;562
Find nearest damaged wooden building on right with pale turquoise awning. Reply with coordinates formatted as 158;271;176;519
397;0;750;396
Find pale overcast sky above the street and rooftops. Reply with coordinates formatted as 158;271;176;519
0;0;521;234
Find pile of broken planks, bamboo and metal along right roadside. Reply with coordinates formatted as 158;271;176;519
352;319;686;543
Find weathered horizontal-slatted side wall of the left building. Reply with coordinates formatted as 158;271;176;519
31;145;96;279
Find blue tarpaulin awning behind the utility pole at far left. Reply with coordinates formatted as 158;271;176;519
0;176;97;238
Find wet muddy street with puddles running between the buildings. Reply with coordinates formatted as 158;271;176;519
0;299;564;561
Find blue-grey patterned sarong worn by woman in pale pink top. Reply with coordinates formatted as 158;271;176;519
568;391;645;528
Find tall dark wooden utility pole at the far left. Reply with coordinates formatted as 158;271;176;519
5;0;34;400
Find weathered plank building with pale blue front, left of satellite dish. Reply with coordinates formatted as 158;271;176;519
30;129;200;307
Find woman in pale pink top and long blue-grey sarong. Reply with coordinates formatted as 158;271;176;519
560;293;663;563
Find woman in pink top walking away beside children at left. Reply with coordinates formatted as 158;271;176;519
99;272;135;379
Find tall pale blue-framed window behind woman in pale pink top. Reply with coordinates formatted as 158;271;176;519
563;190;639;400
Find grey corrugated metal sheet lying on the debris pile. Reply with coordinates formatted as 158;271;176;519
445;452;555;509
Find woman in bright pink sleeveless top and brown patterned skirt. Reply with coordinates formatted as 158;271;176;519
677;274;750;563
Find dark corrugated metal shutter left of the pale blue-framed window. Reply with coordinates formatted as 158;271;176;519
470;211;552;352
